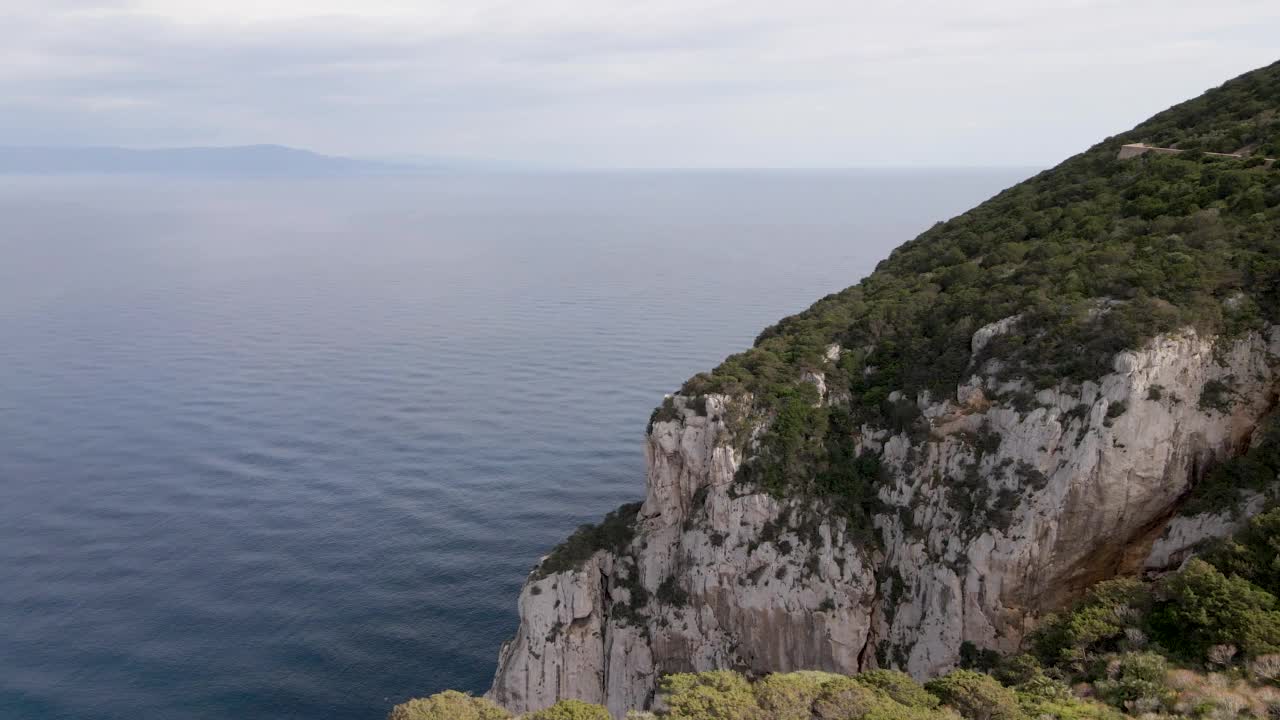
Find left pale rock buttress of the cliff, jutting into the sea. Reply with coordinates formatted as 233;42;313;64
490;396;877;715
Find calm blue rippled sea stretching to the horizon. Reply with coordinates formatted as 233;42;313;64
0;169;1029;720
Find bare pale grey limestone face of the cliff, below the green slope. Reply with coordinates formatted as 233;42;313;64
490;327;1280;716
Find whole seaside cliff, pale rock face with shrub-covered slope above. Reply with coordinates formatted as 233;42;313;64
490;60;1280;716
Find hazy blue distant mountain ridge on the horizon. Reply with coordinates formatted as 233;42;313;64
0;145;431;177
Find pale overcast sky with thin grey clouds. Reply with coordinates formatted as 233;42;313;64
0;0;1280;168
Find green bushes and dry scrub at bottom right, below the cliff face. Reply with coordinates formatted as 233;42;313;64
1024;507;1280;717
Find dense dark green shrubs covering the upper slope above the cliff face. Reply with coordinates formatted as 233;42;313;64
670;63;1280;515
